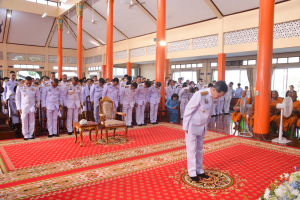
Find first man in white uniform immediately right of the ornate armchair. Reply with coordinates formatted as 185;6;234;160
120;83;138;128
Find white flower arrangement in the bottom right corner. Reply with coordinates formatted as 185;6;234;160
259;167;300;200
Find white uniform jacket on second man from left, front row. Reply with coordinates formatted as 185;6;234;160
41;85;62;110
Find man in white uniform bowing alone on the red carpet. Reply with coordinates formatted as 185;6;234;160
182;81;227;182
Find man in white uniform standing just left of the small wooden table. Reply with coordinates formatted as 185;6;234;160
62;77;83;135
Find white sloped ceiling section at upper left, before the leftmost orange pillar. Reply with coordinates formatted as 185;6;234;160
7;11;54;46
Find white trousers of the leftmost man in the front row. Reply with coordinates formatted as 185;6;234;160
21;112;35;138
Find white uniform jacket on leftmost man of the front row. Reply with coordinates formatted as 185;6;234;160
16;84;40;114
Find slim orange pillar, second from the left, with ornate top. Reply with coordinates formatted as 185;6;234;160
76;2;83;79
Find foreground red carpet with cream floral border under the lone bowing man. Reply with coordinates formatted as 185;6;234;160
0;137;300;200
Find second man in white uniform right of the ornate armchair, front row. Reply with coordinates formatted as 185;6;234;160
135;81;151;126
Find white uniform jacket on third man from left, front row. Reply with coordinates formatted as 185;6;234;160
62;84;83;108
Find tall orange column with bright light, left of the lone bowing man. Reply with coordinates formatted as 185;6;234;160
155;0;166;109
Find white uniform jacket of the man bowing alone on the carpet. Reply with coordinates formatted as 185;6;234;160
182;88;213;135
